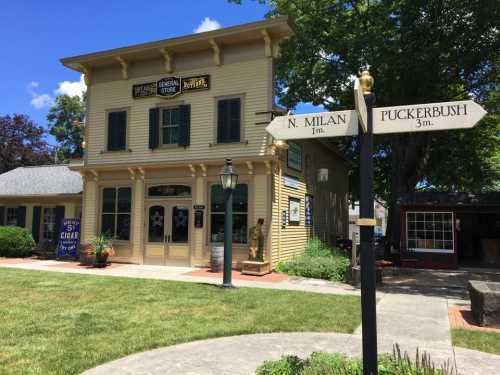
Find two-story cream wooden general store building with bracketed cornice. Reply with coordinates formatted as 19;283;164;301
61;17;349;266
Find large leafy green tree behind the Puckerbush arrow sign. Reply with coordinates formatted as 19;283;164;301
232;0;500;246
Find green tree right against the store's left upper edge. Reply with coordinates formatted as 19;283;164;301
47;95;85;160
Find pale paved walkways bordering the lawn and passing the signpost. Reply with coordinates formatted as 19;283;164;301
0;260;500;375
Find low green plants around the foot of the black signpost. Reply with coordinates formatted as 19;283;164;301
256;346;454;375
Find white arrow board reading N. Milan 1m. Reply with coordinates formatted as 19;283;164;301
266;111;358;140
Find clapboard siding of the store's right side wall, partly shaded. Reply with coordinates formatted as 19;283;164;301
271;141;349;266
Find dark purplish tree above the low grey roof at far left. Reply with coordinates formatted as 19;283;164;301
0;114;53;173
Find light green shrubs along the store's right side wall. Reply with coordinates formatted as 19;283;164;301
276;238;350;281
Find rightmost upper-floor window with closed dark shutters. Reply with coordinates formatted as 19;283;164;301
217;98;242;143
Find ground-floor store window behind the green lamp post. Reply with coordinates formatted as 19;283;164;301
210;184;248;244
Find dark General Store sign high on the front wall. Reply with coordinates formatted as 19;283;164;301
132;74;210;99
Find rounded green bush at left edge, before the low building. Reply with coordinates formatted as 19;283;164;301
0;226;35;258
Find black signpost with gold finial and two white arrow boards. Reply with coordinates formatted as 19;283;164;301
266;71;486;375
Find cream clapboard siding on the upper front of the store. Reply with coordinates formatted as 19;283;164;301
87;58;272;166
